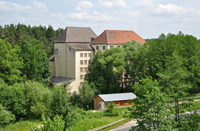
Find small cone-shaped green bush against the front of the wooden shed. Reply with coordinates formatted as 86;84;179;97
104;102;118;116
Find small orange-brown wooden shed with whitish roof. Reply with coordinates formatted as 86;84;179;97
94;92;137;110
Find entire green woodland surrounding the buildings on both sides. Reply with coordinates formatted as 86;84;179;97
0;24;200;131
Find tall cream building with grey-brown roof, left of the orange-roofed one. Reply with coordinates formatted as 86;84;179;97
49;27;97;93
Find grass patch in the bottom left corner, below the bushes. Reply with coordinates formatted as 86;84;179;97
0;120;42;131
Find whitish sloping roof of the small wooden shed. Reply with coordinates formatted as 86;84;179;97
98;93;136;102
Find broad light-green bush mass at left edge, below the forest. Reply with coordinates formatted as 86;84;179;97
0;81;51;120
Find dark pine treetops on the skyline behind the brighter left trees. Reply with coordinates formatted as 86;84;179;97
0;24;63;57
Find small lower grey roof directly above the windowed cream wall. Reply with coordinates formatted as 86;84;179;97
69;43;92;51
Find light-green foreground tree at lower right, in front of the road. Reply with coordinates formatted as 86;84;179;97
131;78;173;131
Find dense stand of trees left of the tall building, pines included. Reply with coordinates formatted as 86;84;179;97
0;24;63;85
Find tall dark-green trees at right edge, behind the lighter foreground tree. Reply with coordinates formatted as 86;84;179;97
147;32;200;92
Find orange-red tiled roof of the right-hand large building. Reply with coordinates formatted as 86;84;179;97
91;30;146;44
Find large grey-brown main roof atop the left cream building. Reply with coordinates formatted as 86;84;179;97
54;27;97;43
